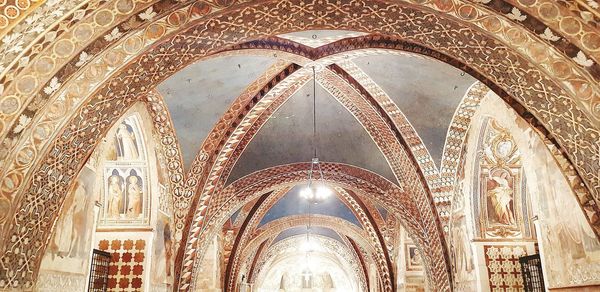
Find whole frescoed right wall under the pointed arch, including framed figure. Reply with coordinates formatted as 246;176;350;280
464;93;600;289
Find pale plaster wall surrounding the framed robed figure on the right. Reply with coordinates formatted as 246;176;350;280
465;93;600;291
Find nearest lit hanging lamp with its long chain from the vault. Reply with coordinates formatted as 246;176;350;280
300;66;332;203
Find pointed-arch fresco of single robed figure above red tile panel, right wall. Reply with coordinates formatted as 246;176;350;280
466;116;535;291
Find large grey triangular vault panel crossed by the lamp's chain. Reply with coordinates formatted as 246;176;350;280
228;82;396;183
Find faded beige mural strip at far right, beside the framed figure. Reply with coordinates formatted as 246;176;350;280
528;125;600;287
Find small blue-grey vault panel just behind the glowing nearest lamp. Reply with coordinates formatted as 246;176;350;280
259;185;361;227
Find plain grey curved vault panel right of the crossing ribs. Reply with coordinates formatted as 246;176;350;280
354;55;476;166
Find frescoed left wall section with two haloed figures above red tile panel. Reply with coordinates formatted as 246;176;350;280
90;109;161;291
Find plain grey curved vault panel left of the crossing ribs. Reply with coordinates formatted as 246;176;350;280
158;56;275;167
